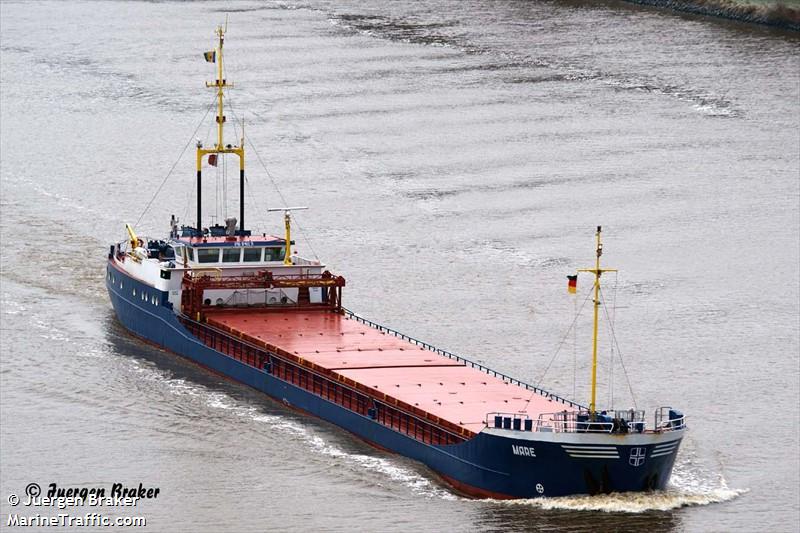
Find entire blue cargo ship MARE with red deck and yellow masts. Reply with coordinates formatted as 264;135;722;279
106;26;686;498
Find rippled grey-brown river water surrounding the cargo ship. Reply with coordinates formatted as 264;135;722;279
0;0;800;531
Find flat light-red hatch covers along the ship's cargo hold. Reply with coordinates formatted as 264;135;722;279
206;309;574;433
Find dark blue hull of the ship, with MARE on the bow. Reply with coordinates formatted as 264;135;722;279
106;262;683;498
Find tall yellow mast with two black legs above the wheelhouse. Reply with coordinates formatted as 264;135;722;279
196;23;246;236
